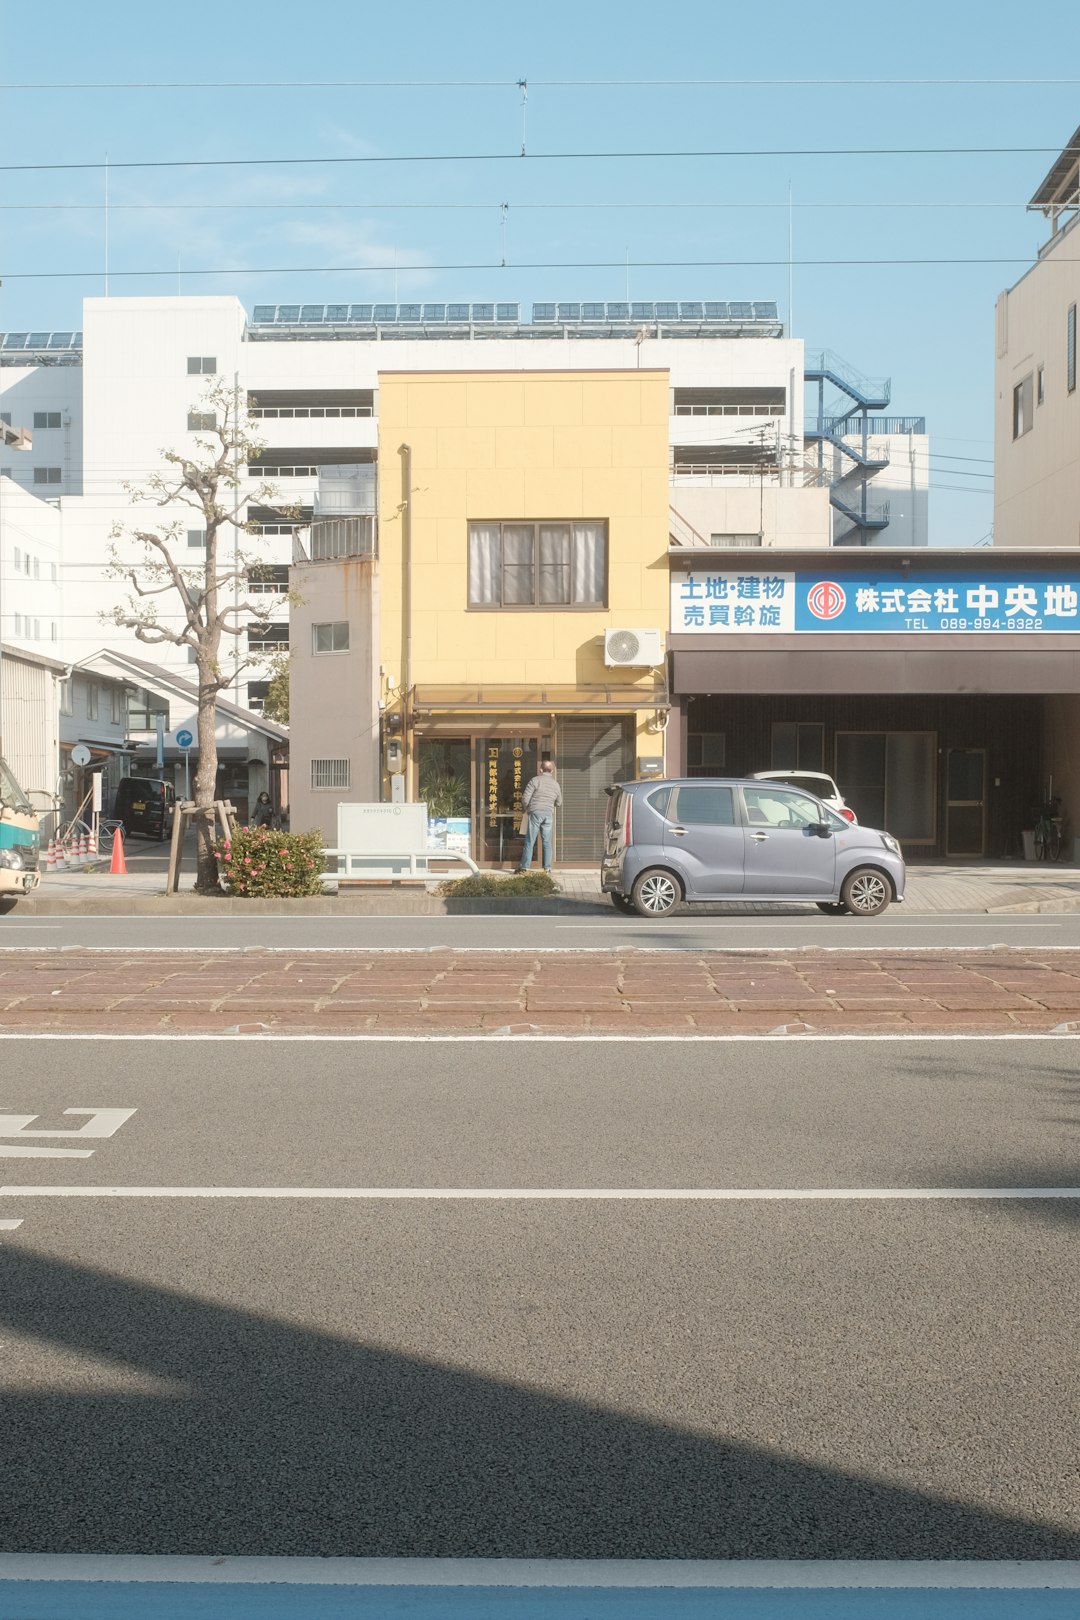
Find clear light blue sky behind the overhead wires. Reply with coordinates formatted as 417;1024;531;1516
0;0;1080;544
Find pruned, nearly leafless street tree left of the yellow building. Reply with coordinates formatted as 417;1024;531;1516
104;382;296;893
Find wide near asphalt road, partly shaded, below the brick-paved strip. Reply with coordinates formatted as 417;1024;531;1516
0;1038;1080;1558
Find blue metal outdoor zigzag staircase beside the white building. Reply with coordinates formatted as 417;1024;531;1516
803;350;892;546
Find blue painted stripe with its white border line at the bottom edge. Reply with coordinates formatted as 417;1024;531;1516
0;1554;1080;1620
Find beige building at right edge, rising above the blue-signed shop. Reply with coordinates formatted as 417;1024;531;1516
994;130;1080;548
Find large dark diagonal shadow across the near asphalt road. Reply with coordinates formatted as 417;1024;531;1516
0;1247;1080;1558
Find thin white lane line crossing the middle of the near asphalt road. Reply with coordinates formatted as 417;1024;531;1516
0;1186;1080;1204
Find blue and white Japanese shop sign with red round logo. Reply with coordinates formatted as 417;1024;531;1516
672;569;1080;635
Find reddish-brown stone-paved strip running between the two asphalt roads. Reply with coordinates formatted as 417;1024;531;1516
0;948;1080;1035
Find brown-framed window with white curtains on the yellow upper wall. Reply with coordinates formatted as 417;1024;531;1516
468;520;607;608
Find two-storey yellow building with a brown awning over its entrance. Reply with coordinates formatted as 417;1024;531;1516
377;371;669;865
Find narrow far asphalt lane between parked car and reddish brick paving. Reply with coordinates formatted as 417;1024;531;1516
0;907;1080;951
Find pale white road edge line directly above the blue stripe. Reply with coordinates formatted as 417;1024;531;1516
0;1552;1080;1591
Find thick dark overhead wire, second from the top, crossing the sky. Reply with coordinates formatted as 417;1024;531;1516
0;146;1080;175
